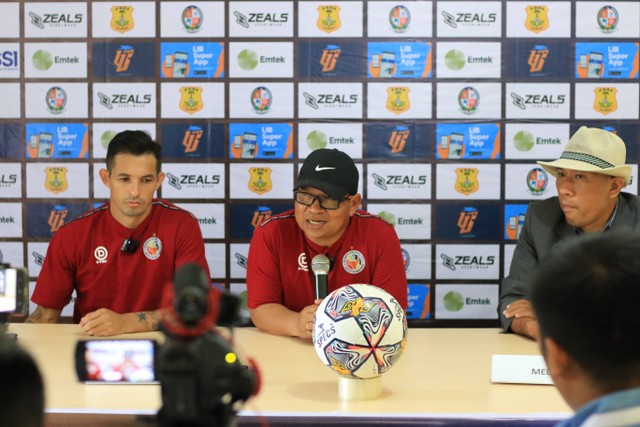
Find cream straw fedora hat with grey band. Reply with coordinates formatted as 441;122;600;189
538;126;631;185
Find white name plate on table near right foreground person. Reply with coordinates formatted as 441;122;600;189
491;354;553;384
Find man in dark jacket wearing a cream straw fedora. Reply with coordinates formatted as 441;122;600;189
498;126;640;339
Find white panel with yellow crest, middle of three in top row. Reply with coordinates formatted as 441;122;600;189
298;1;363;38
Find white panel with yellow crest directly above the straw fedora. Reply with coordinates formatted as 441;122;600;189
574;81;640;120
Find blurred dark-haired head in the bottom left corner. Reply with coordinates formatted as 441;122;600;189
0;335;44;427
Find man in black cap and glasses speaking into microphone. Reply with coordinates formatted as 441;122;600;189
247;149;407;339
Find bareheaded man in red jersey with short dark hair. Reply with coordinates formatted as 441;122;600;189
26;131;210;336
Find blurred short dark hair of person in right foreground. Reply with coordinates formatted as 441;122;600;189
531;231;640;389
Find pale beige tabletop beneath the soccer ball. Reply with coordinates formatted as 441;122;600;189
9;324;572;419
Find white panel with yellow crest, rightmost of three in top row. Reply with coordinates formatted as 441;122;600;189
506;1;571;38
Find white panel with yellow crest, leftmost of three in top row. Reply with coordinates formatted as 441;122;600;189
91;1;156;39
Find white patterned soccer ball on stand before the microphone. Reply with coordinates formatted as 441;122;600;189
313;284;407;379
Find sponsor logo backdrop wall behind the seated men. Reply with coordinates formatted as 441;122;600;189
0;0;640;326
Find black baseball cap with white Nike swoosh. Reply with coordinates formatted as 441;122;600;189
293;148;359;200
